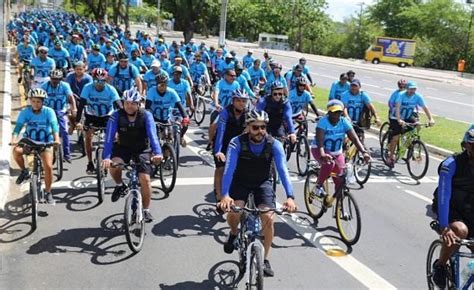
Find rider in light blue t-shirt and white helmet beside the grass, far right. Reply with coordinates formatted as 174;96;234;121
386;81;435;168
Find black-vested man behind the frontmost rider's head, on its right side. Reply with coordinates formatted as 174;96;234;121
257;81;296;144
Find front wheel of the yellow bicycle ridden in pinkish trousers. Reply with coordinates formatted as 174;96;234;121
336;189;362;246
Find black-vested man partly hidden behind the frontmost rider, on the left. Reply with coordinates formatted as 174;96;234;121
214;90;249;207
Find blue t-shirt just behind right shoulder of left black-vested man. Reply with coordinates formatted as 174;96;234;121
146;87;180;121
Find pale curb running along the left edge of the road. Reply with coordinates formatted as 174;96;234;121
0;48;12;210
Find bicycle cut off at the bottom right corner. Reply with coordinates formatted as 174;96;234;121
426;221;474;290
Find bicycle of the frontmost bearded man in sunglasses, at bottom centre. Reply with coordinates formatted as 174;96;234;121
232;193;284;289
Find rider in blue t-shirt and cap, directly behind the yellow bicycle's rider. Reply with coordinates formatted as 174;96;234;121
341;79;381;143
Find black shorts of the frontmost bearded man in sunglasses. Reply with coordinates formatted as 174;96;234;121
229;180;275;207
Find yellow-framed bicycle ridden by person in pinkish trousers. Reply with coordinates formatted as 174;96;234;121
304;162;362;245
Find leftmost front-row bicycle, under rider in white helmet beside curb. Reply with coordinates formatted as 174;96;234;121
9;138;55;231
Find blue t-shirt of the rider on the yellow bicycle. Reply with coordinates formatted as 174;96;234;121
315;116;352;155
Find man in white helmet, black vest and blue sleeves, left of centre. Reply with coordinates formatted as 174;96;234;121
102;88;163;222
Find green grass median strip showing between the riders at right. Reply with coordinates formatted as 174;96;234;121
313;88;469;152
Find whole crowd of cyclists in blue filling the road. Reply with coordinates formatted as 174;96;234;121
8;10;474;283
